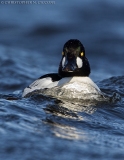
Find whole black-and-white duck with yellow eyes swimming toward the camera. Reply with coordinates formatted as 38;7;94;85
22;39;101;97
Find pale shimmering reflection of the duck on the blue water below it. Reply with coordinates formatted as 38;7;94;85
44;100;97;141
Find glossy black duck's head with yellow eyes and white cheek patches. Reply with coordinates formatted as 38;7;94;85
58;39;90;77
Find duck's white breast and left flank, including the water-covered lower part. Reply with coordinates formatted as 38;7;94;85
22;77;102;99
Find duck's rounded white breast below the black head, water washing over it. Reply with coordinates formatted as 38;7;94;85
40;77;103;101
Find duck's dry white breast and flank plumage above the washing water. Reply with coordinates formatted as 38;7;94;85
22;77;101;97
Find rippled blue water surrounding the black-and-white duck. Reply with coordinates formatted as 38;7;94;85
0;0;124;160
